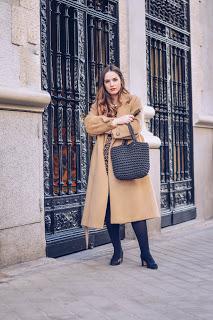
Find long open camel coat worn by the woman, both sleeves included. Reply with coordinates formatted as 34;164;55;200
81;94;159;228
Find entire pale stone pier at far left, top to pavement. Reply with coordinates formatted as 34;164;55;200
0;0;50;266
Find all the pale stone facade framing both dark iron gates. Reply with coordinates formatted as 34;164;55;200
0;0;213;266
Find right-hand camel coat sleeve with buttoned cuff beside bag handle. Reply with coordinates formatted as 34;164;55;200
112;96;142;139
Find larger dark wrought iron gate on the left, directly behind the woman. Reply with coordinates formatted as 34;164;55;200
41;0;119;257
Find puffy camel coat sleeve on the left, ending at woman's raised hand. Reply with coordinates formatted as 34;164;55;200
84;103;117;136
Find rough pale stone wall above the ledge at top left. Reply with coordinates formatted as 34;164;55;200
0;0;40;89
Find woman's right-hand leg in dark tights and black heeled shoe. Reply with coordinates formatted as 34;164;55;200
132;220;158;269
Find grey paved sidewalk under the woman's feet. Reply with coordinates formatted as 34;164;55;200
0;221;213;320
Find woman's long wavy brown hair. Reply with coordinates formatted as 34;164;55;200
96;65;129;117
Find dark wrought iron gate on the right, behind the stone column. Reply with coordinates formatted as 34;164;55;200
146;0;196;227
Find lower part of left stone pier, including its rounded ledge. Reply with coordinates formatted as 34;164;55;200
0;86;49;266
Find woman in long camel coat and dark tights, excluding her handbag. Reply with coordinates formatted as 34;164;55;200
82;66;159;269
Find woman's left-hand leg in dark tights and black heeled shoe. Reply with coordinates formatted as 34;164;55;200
105;198;123;266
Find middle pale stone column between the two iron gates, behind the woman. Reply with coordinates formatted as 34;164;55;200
120;0;160;237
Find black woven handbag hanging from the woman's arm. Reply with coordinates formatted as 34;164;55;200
111;123;150;180
